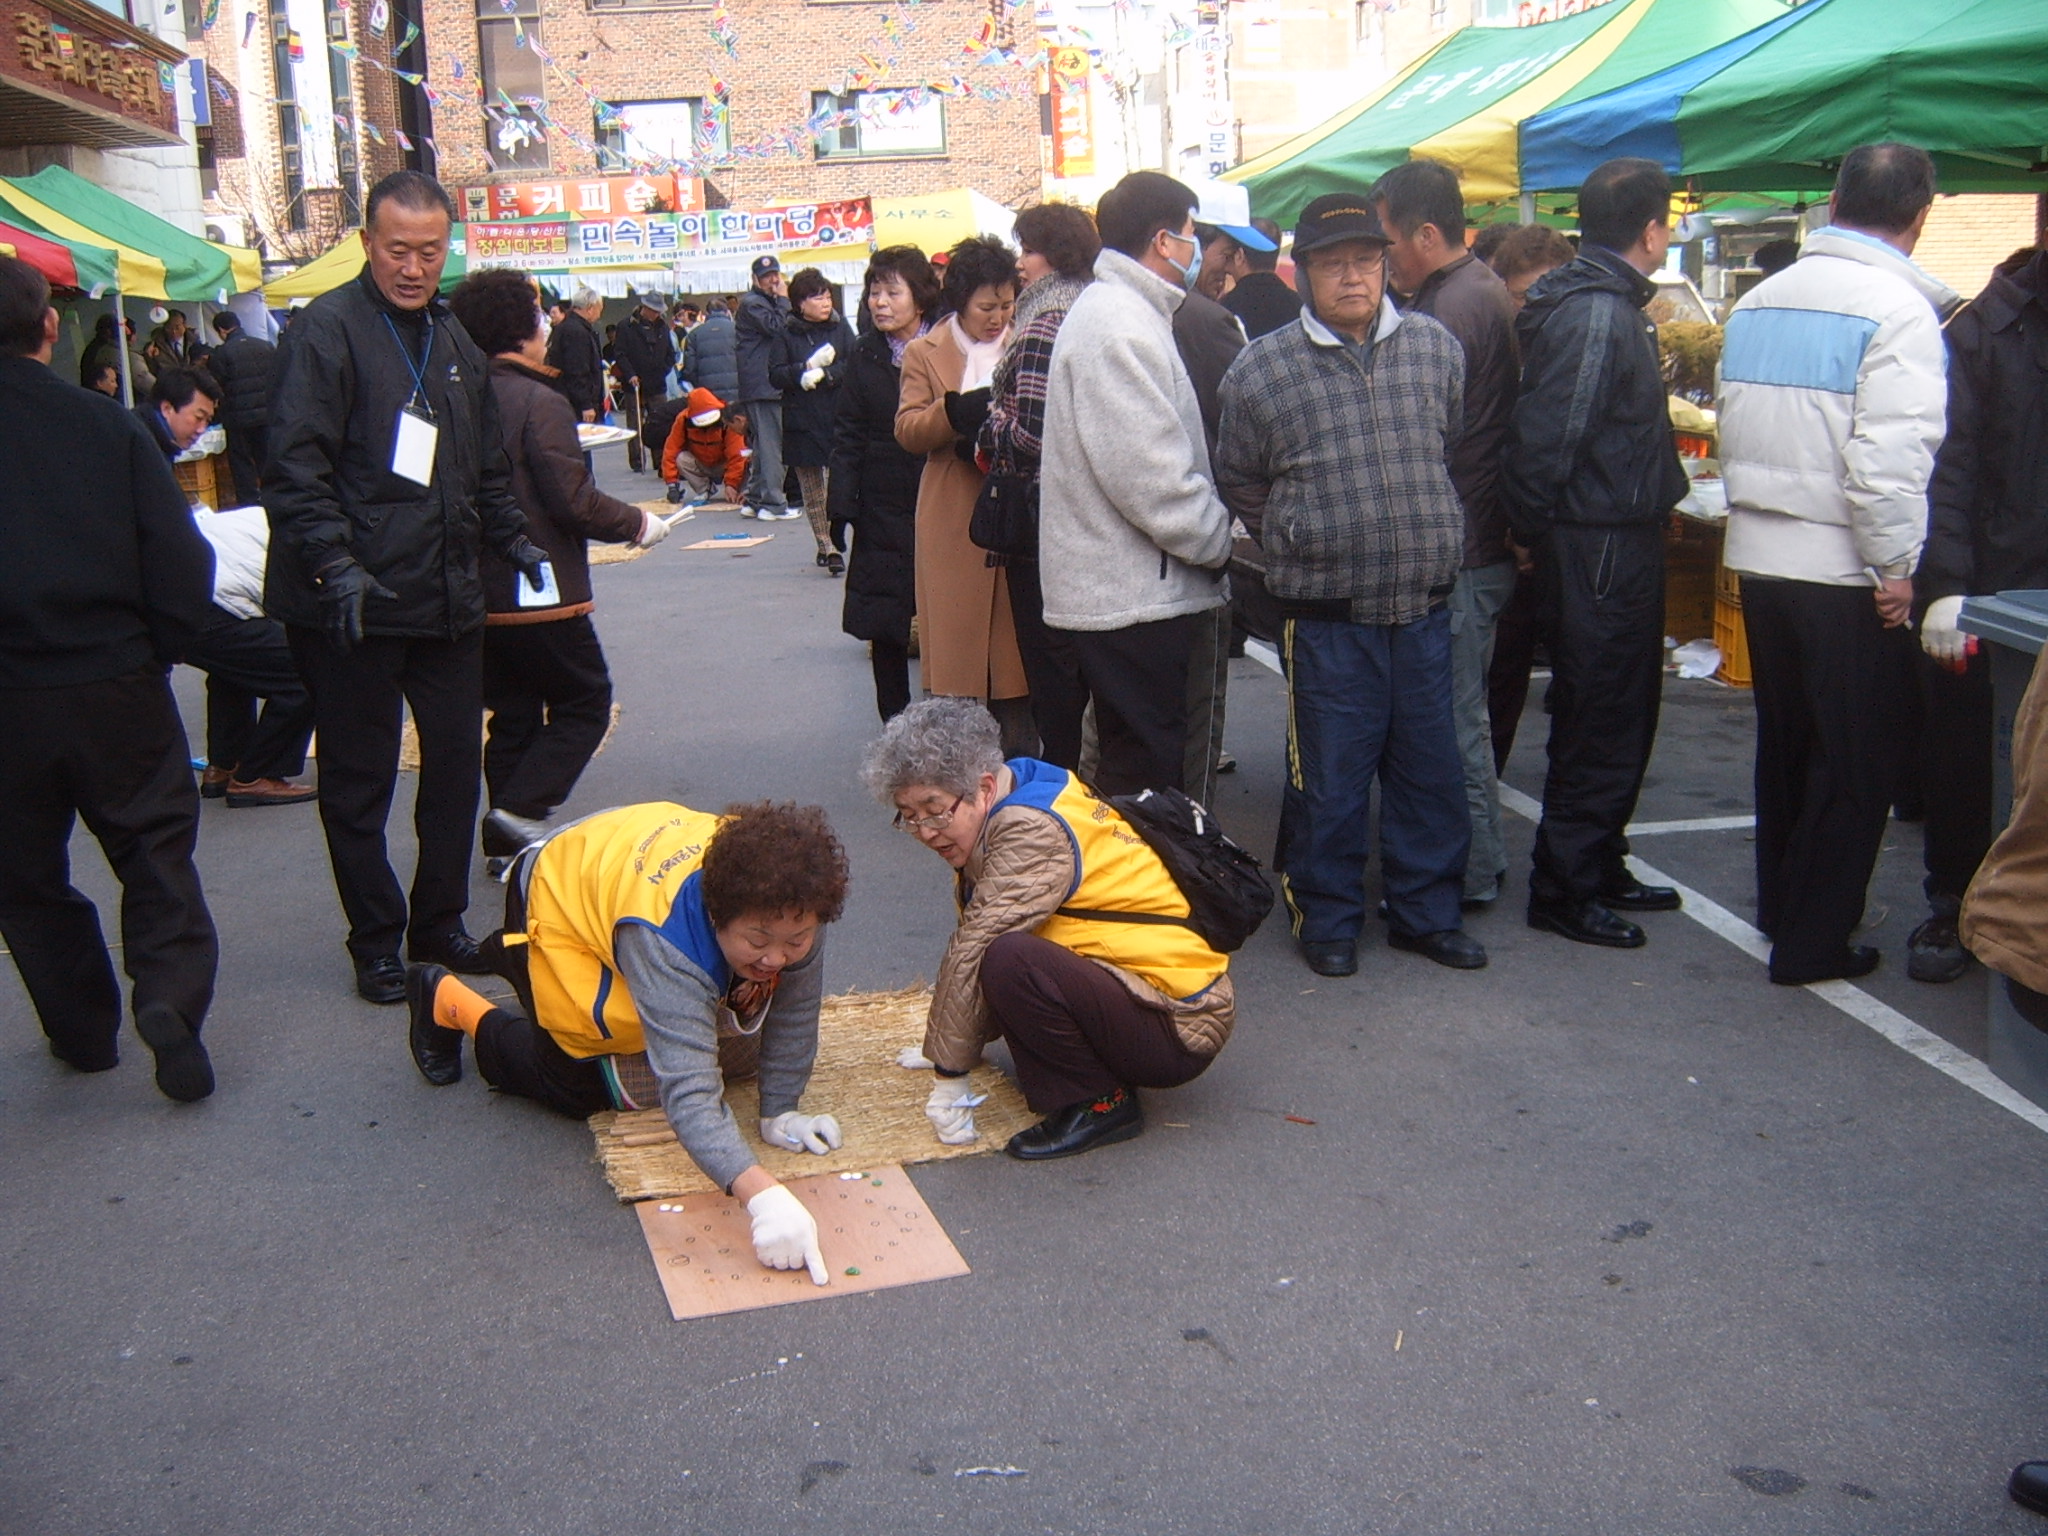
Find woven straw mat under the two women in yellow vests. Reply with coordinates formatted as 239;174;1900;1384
590;985;1038;1202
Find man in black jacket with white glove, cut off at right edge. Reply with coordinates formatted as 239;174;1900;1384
1907;250;2048;981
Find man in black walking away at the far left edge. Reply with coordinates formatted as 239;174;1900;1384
0;256;219;1100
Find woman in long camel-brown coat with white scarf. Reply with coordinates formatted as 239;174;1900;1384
897;238;1036;752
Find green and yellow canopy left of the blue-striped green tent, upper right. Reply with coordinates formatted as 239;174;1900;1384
1225;0;1786;227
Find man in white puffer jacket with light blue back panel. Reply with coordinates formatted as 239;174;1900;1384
1720;143;1956;985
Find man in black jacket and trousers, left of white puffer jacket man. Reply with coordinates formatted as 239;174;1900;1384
1501;160;1686;948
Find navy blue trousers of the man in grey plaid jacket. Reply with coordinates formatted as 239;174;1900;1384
1280;608;1473;942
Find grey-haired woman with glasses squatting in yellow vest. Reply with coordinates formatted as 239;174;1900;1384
862;698;1235;1159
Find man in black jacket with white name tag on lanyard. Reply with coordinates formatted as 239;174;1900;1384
264;170;547;1004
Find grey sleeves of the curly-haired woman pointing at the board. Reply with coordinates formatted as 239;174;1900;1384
612;924;825;1190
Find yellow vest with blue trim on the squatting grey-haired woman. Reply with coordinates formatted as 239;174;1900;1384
991;758;1231;997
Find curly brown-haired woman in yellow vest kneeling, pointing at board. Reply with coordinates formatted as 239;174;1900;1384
406;803;846;1284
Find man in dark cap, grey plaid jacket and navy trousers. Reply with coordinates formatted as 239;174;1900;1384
1217;193;1487;977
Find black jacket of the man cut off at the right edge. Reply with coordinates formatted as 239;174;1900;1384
1913;252;2048;604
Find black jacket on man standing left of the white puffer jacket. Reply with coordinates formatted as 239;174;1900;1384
1501;246;1688;543
